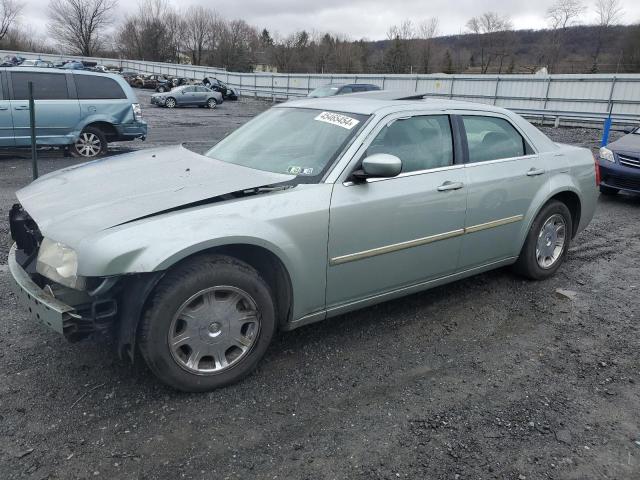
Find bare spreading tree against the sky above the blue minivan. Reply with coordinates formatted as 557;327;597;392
49;0;118;57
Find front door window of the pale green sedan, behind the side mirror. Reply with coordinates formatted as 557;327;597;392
367;115;453;173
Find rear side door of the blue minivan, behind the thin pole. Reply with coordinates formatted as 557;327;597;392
7;71;80;146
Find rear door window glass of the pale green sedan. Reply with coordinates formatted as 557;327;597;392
462;116;532;163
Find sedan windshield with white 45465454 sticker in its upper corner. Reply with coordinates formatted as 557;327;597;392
206;108;367;180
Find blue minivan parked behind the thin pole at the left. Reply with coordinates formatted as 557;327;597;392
0;67;147;158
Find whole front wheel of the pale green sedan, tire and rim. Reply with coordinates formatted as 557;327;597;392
139;255;276;392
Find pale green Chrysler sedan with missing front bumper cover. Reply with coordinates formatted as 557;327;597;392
9;92;597;391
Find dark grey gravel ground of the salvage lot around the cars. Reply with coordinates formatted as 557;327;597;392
0;93;640;480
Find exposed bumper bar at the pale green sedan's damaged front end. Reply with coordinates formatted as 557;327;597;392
8;245;80;335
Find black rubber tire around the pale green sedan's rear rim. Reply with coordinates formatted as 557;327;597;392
514;200;573;280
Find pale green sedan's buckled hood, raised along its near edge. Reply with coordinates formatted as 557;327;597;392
16;146;295;247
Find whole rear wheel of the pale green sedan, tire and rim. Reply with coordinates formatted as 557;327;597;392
515;200;573;280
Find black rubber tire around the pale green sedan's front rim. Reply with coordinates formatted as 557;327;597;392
138;255;276;392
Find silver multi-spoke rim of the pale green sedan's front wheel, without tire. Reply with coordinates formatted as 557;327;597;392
167;286;260;375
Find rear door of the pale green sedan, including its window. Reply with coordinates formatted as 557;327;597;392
457;112;548;270
